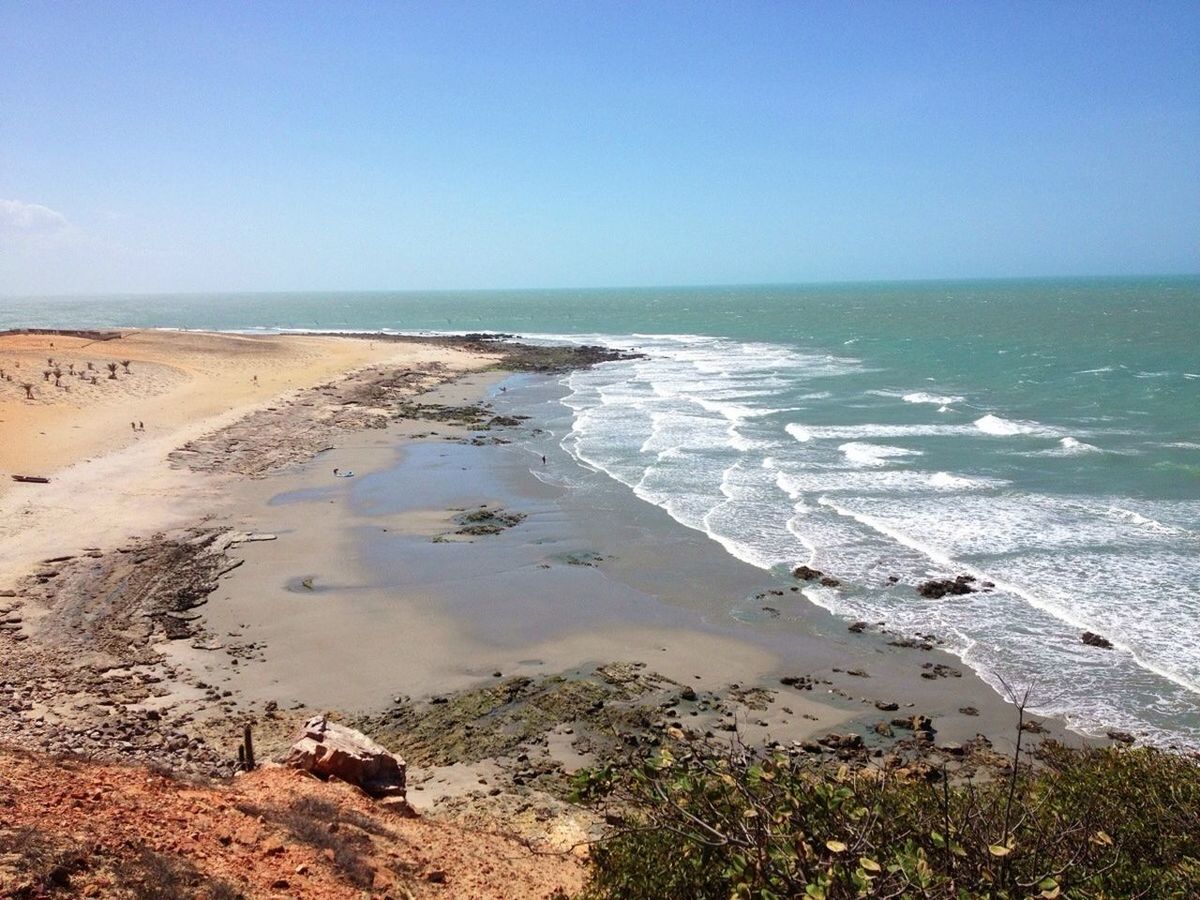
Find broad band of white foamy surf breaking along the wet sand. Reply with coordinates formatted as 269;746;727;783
549;328;1200;748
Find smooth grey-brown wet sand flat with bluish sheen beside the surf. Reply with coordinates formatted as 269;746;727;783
182;374;1056;749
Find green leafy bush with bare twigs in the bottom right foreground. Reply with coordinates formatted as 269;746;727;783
576;742;1200;900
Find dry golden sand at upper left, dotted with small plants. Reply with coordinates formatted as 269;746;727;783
0;331;491;588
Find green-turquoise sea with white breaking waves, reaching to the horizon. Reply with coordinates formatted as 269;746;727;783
0;277;1200;746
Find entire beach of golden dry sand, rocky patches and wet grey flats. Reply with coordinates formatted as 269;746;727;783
0;331;1062;806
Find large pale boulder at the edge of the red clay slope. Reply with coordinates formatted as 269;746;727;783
282;715;407;797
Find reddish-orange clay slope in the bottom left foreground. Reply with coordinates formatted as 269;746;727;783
0;749;586;900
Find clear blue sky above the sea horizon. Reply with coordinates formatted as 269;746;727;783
0;0;1200;295
